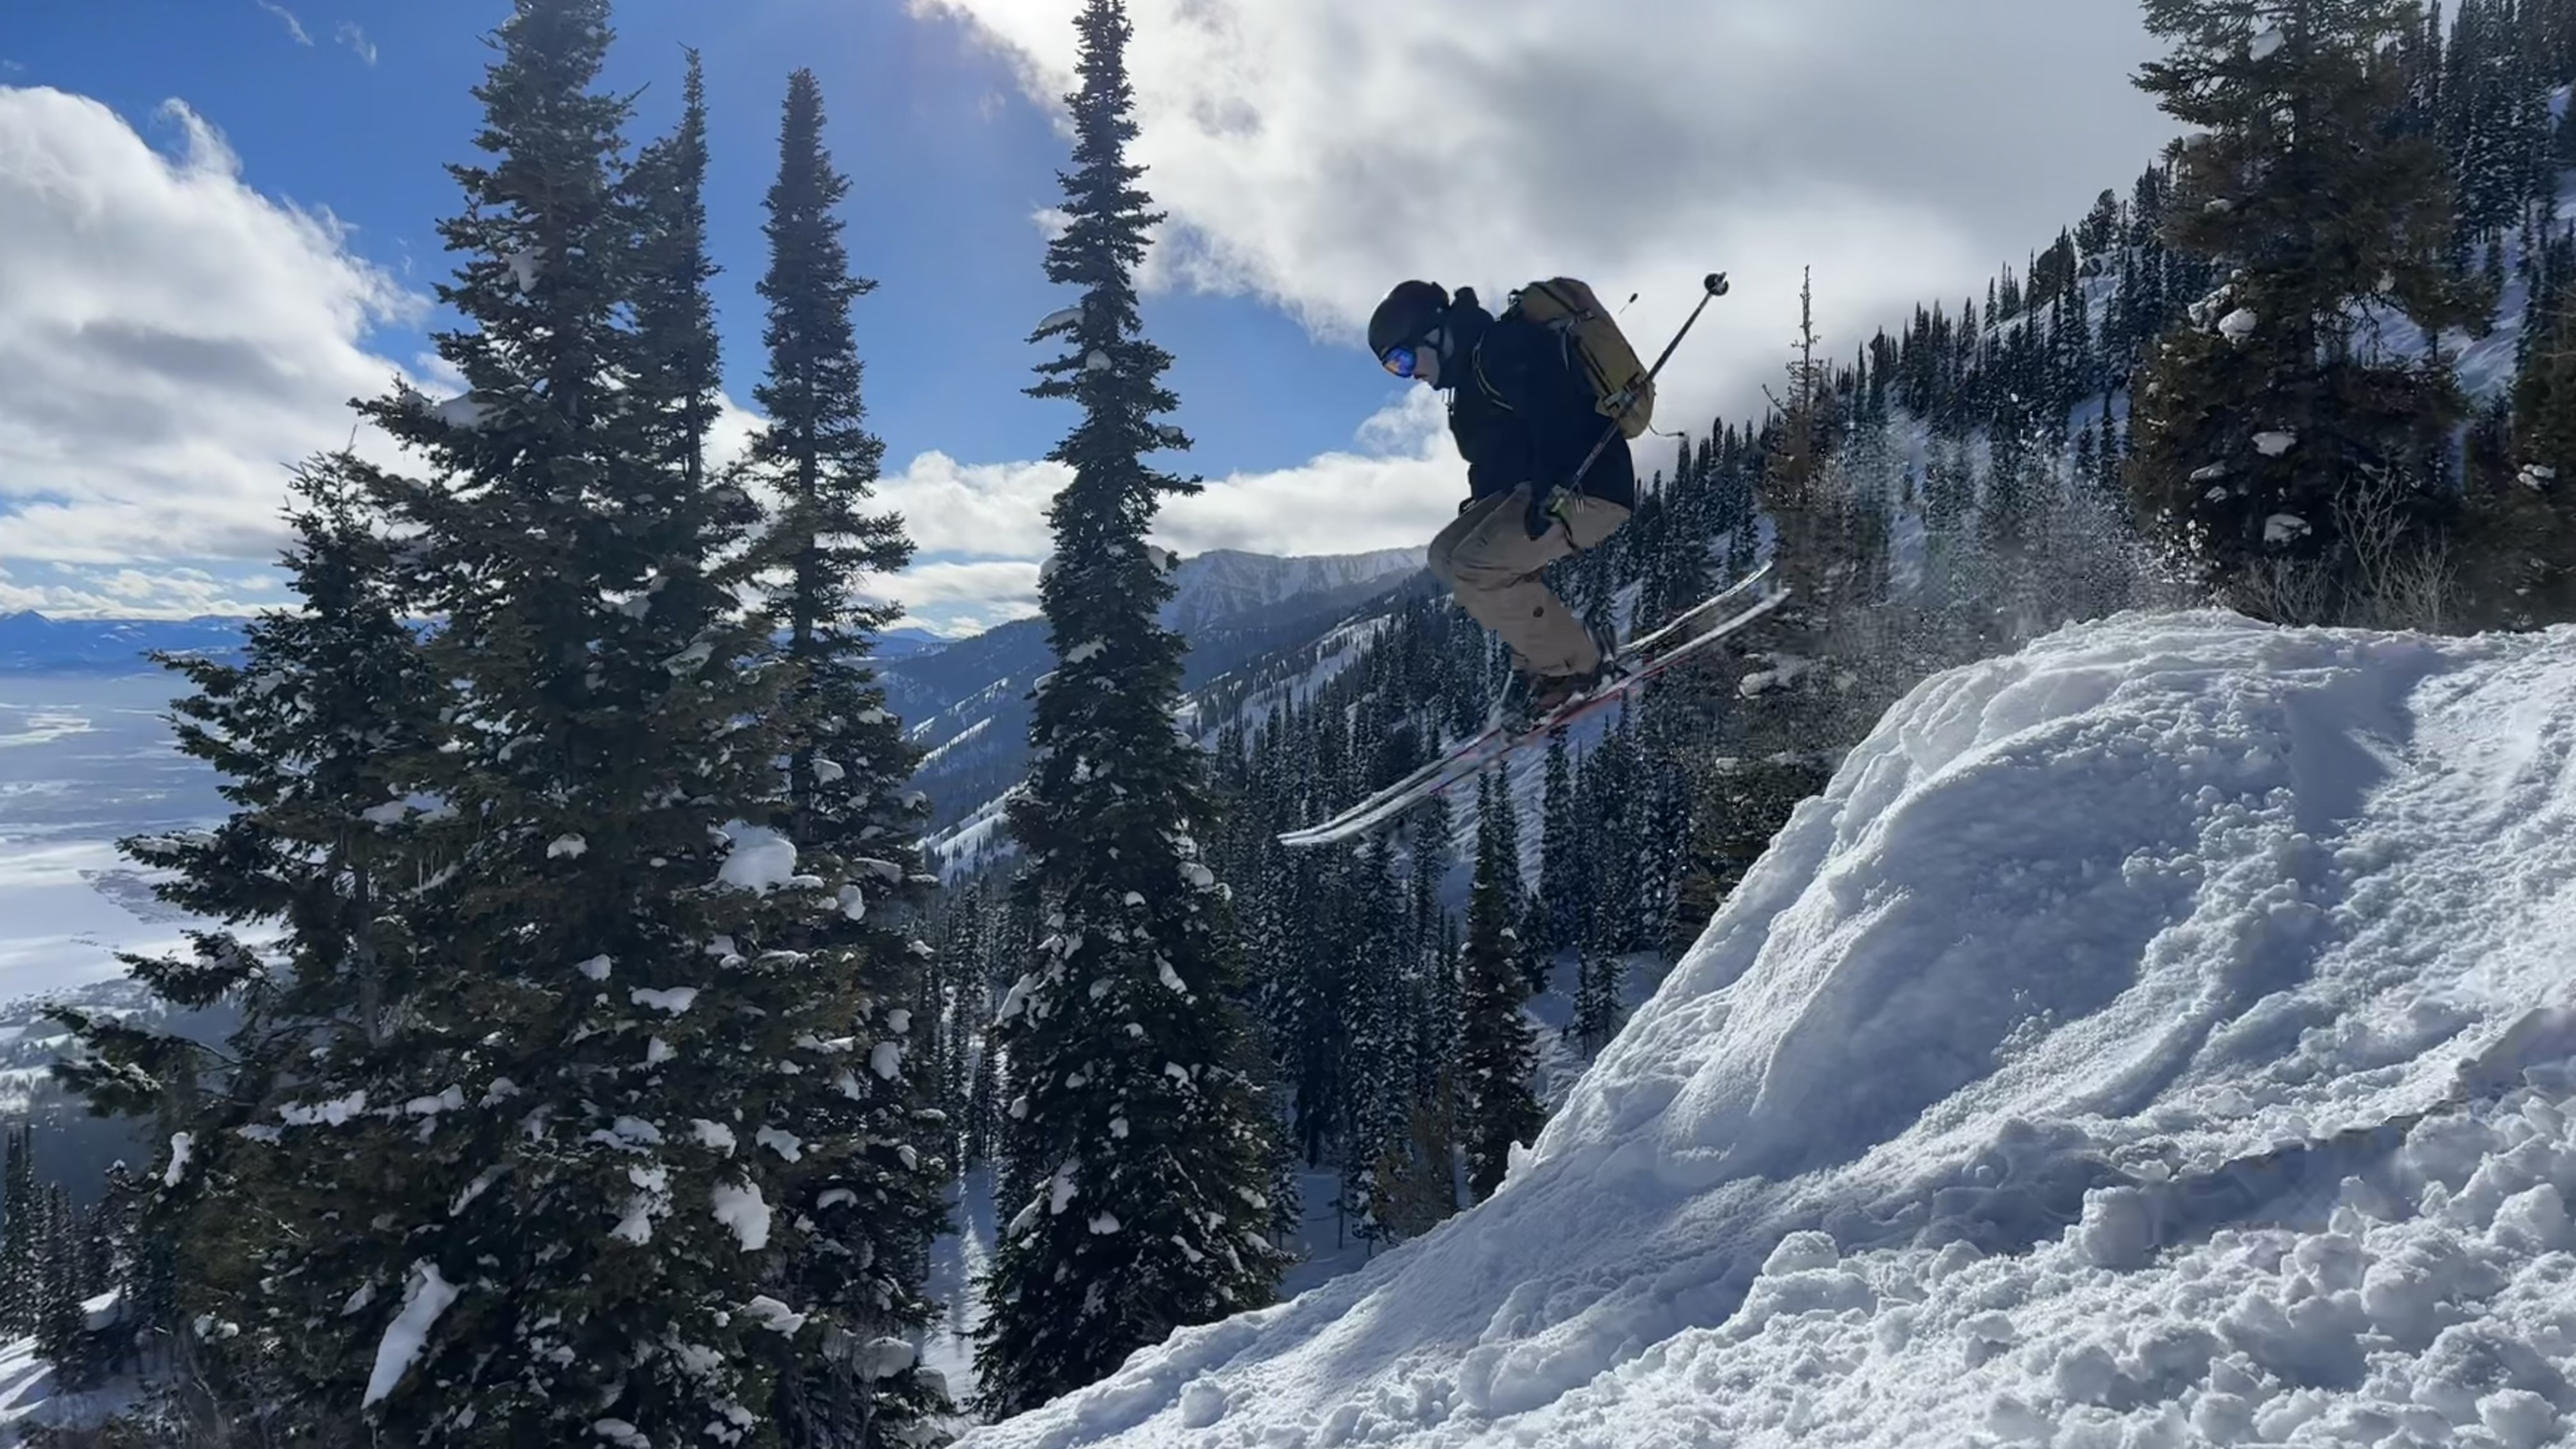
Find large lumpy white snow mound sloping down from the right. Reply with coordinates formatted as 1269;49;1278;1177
966;613;2576;1449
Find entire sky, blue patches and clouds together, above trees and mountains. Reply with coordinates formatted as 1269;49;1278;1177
0;0;2169;632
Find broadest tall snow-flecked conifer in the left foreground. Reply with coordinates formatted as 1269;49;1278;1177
284;0;901;1446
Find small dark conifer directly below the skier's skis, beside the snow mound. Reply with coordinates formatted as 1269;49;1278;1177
1458;774;1545;1199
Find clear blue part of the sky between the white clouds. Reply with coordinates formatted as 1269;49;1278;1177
0;0;1388;472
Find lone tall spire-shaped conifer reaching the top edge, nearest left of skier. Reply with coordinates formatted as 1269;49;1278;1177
976;0;1280;1413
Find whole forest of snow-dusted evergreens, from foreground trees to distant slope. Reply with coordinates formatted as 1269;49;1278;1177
15;0;2576;1446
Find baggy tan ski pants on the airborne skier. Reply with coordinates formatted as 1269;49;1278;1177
1430;485;1628;675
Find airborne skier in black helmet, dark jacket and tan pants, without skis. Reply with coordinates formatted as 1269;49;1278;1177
1368;281;1636;730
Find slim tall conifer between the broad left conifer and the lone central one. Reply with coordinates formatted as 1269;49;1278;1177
749;70;951;1446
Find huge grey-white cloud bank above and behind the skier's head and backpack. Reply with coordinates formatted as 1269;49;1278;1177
909;0;2174;425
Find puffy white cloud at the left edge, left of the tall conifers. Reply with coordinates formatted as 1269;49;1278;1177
0;88;425;580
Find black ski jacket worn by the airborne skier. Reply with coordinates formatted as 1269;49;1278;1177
1440;302;1636;508
